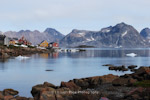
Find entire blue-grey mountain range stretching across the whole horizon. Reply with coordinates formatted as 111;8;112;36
0;23;150;47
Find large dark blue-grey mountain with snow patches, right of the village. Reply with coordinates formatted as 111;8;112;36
60;23;149;47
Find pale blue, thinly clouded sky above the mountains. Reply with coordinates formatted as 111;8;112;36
0;0;150;34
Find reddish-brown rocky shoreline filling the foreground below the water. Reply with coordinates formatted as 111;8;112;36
0;66;150;100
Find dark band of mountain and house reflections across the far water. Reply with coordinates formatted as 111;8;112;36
37;49;150;59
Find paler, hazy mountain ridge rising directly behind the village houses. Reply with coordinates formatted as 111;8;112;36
3;28;64;45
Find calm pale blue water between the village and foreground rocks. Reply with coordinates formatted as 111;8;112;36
0;48;150;97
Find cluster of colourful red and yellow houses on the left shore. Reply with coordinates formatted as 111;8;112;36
0;35;59;49
